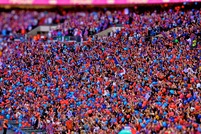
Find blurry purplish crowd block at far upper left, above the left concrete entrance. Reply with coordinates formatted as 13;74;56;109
0;10;66;38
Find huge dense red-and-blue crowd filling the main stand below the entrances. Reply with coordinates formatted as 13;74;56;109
0;6;201;134
